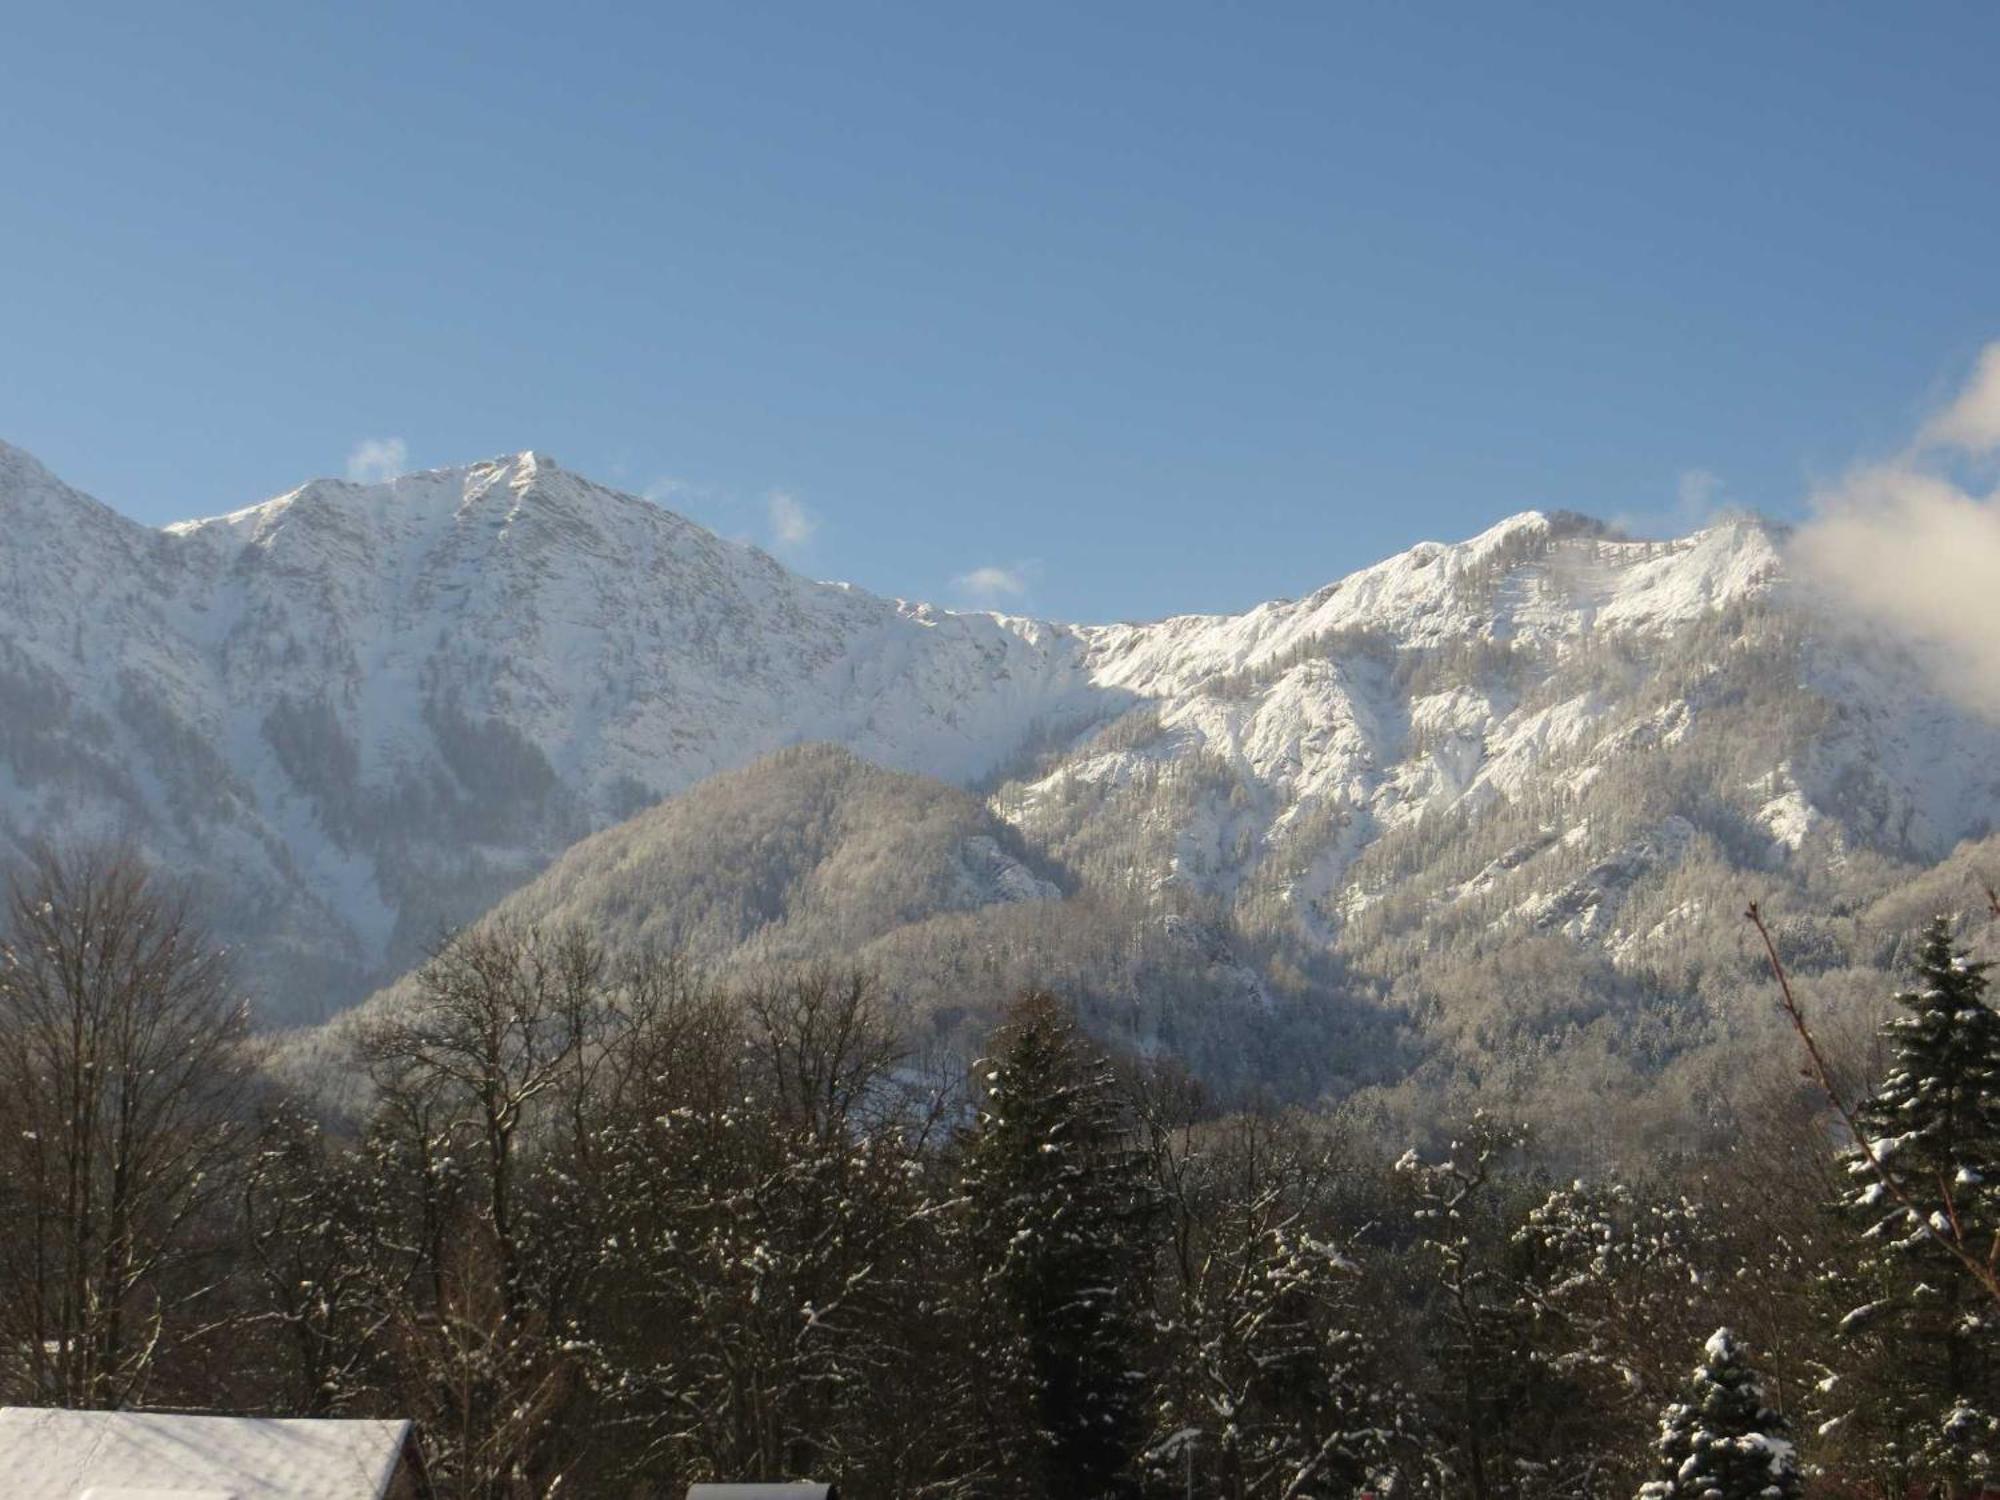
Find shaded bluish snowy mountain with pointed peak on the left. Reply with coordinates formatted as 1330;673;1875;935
0;448;1102;1016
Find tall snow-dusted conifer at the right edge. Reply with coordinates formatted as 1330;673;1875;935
1832;916;2000;1490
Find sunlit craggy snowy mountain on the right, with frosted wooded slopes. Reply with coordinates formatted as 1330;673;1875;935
994;516;2000;1136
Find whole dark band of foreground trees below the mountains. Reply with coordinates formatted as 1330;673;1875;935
0;852;2000;1500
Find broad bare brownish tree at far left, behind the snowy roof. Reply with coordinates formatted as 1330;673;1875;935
0;850;248;1406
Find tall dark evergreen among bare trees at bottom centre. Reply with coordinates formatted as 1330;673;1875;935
964;994;1158;1500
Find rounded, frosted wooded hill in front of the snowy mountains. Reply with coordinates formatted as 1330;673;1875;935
316;744;1338;1096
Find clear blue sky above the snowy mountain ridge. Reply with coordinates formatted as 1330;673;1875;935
0;0;2000;618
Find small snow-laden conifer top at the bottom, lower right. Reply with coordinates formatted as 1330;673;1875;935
1640;1328;1800;1500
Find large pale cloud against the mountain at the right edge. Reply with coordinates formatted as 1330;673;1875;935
1792;342;2000;716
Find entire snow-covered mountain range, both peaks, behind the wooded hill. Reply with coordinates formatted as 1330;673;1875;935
0;446;2000;1056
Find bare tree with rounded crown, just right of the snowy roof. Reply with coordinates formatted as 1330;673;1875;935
362;924;616;1496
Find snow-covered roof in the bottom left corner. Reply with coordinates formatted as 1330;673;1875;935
0;1406;410;1500
